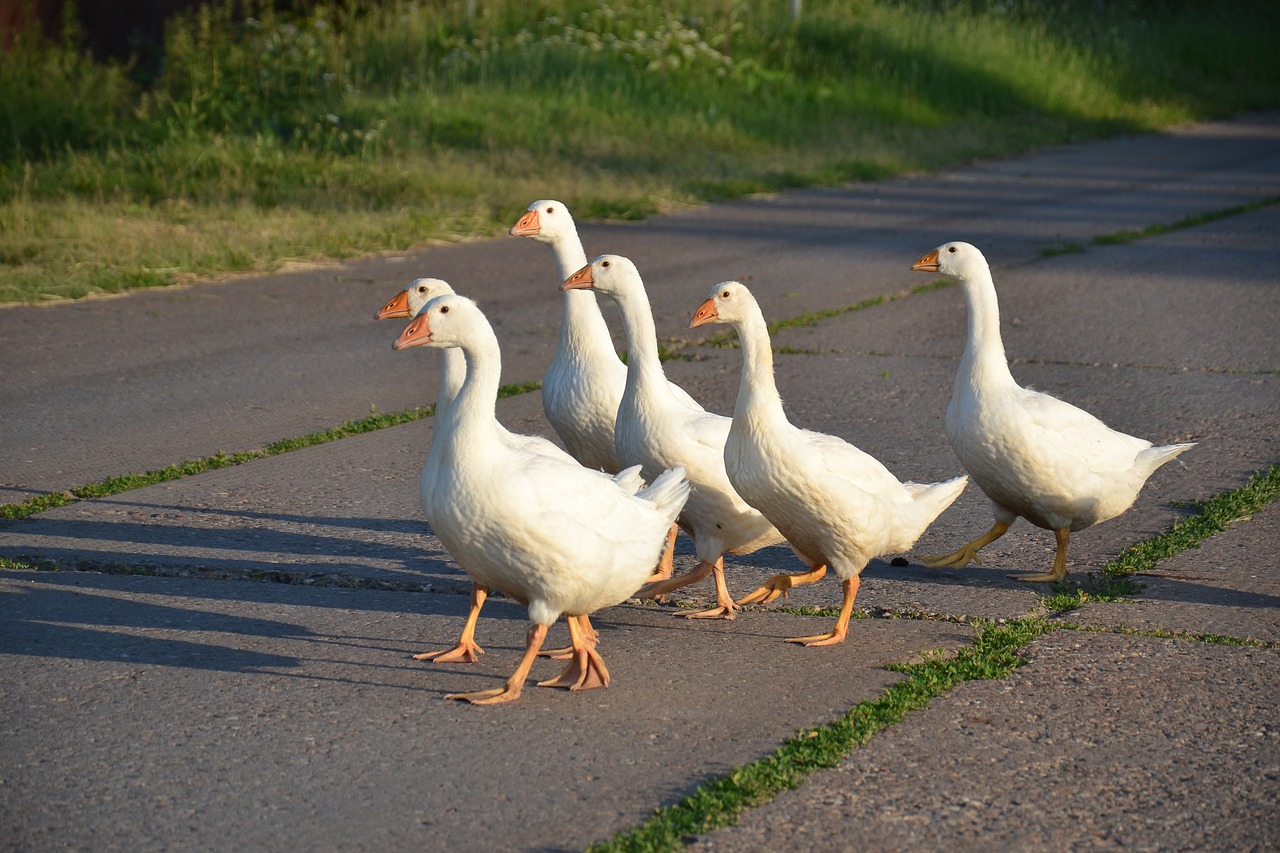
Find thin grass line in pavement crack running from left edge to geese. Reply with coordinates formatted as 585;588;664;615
0;382;541;519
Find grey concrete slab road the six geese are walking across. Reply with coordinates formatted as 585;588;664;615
0;115;1280;850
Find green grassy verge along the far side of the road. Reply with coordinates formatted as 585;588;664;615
0;0;1280;302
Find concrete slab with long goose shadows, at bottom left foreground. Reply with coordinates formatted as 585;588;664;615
0;563;972;850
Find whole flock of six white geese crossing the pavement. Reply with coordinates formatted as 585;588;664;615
376;200;1192;704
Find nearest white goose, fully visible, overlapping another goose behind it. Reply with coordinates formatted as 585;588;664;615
393;295;689;704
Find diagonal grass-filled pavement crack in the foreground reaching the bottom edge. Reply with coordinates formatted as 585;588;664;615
588;619;1053;853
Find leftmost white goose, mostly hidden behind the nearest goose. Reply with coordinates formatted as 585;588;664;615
374;278;644;663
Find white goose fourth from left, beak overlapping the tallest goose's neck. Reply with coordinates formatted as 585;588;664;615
563;255;783;619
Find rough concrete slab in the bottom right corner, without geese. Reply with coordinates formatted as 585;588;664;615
690;630;1280;853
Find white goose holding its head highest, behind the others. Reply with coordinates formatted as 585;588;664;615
508;199;701;580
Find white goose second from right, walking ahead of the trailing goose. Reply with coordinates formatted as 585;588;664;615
689;282;969;646
